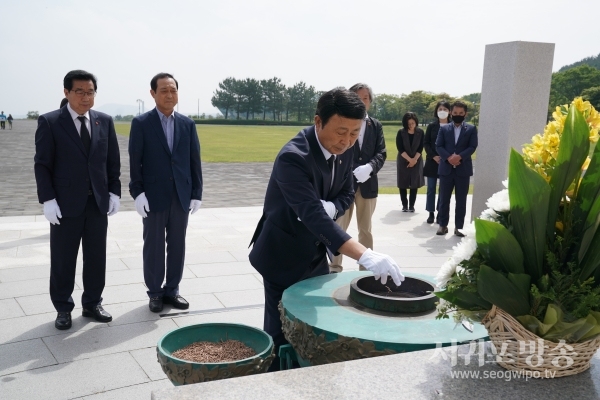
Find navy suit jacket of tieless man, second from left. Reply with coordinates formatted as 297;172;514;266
129;108;202;212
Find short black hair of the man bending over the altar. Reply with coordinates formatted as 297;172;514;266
315;87;367;126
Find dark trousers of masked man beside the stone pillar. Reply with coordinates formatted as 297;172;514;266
438;170;471;229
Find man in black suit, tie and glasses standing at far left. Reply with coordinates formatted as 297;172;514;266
34;70;121;329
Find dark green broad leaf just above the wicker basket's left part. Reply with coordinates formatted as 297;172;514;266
477;264;530;317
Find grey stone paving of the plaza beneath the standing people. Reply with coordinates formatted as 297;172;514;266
0;117;470;400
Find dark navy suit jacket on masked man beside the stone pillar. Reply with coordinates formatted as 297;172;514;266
435;122;478;176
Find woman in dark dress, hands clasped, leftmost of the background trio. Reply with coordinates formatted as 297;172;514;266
396;112;425;212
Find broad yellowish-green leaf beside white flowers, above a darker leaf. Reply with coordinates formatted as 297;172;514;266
475;219;525;274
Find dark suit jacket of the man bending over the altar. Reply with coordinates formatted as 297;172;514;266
250;126;354;286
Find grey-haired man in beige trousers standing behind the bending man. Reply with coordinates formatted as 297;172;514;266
329;83;387;272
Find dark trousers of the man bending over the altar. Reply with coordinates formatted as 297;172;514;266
263;244;329;371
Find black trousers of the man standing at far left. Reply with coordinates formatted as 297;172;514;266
50;195;108;312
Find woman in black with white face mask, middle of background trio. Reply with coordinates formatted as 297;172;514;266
423;100;450;224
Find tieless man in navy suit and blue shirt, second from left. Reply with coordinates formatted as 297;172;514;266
129;73;202;312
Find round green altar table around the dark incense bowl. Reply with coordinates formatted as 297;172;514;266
280;271;487;366
